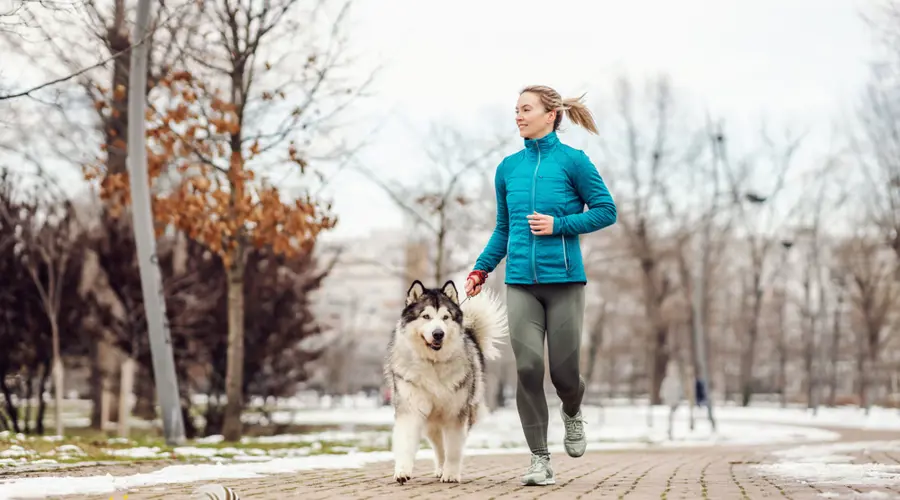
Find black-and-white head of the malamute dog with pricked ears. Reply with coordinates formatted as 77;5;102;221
402;280;462;351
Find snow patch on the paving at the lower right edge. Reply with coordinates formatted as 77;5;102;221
754;441;900;486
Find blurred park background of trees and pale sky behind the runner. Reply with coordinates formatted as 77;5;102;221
0;0;900;464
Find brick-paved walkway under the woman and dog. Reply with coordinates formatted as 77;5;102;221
31;431;900;500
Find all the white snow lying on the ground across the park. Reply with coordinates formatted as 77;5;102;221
0;398;900;498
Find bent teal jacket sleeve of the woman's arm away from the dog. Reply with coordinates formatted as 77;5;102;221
553;151;617;236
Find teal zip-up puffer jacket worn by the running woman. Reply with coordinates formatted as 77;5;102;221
475;132;616;284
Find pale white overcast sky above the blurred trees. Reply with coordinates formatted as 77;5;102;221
0;0;874;242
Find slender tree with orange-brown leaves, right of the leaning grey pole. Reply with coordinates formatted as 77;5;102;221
153;0;374;440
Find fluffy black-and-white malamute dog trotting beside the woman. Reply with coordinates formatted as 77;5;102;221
384;280;507;484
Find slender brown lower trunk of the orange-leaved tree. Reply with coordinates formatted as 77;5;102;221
222;254;244;441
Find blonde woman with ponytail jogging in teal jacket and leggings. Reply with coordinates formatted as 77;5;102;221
466;86;616;485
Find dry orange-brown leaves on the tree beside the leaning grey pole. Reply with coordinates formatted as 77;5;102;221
84;72;336;265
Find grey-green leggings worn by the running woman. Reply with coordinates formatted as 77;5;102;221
506;283;585;454
